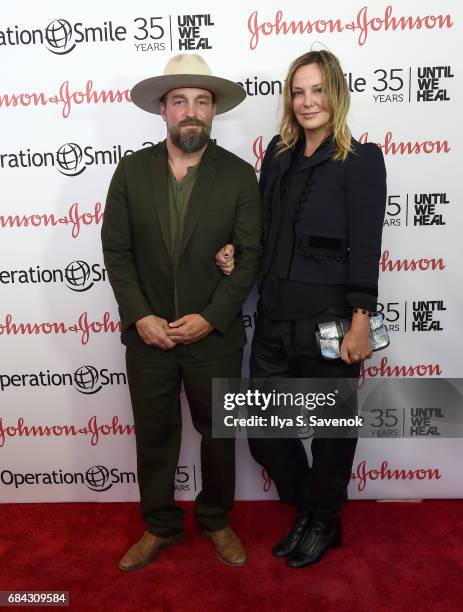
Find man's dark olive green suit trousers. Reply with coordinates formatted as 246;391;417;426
126;341;242;537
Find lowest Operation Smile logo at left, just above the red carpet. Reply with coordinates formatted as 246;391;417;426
0;465;137;493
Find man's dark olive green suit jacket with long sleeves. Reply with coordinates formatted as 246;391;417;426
102;141;261;359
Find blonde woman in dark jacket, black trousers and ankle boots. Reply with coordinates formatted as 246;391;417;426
219;50;386;567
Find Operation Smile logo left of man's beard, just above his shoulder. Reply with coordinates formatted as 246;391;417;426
0;141;154;176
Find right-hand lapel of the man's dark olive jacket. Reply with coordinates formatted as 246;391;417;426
179;141;220;257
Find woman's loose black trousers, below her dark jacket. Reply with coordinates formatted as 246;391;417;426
249;308;360;520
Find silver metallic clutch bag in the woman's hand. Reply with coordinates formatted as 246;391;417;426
315;313;390;359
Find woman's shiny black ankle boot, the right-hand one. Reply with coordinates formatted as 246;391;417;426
287;516;342;567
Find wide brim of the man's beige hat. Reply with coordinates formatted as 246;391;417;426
130;74;246;115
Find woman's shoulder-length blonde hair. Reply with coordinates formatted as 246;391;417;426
277;50;352;160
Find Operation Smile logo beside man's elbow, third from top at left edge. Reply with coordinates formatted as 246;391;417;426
0;259;106;293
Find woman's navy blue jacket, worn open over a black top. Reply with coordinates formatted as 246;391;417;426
260;135;386;311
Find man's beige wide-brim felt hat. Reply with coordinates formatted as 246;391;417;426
130;53;246;115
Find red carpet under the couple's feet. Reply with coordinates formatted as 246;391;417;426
0;501;463;612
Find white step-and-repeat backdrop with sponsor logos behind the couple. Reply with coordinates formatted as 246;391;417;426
0;0;463;502
